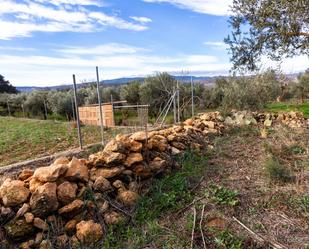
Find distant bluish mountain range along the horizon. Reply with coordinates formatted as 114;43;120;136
16;76;219;92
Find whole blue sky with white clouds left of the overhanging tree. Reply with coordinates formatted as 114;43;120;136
0;0;309;86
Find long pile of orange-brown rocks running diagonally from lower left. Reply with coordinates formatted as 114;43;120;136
0;113;224;249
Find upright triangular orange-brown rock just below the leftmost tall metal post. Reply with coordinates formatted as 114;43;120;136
65;157;89;182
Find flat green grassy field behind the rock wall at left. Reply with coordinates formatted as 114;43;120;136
0;117;131;166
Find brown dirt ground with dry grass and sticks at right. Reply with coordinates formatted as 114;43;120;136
156;123;309;249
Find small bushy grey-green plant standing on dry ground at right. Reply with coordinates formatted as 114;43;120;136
265;156;292;182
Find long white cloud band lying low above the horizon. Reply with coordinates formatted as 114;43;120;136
0;43;309;86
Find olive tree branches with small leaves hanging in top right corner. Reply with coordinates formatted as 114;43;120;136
225;0;309;70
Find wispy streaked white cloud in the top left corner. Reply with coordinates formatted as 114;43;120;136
0;0;147;40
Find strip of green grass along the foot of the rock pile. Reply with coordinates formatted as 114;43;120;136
102;152;208;249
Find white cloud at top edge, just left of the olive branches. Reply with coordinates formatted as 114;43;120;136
143;0;233;16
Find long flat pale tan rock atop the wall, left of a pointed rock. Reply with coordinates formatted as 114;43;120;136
33;163;68;182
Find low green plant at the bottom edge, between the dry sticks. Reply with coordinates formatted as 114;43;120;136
215;230;244;249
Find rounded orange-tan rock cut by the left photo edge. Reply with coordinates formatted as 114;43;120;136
0;179;30;207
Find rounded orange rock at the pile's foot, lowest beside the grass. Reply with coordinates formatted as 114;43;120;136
76;220;103;245
